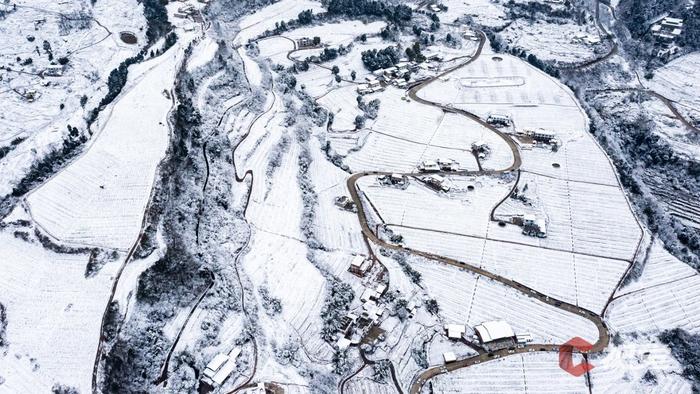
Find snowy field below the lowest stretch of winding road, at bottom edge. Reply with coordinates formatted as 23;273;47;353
432;352;588;393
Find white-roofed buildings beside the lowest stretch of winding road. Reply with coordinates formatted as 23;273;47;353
443;320;532;363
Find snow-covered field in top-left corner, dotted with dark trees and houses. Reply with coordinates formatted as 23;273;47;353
0;0;145;196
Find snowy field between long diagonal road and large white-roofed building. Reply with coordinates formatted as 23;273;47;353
413;262;598;343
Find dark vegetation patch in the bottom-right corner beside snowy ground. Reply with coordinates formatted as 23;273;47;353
659;328;700;393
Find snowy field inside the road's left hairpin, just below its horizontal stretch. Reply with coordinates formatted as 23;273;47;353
358;173;510;237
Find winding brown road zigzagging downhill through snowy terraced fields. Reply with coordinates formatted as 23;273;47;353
347;32;610;394
